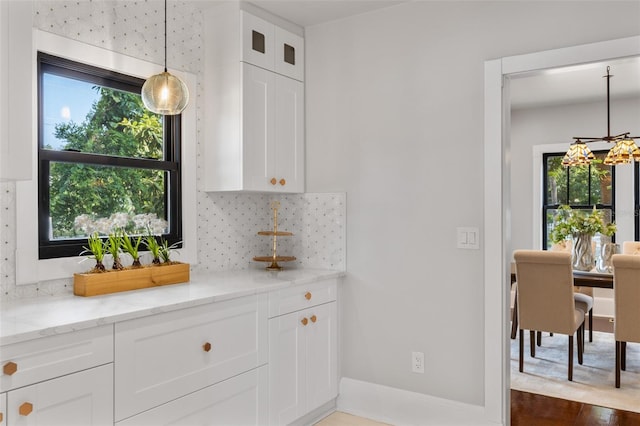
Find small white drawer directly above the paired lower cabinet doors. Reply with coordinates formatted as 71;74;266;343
269;279;337;318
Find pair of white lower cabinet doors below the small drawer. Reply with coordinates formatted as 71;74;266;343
269;294;338;425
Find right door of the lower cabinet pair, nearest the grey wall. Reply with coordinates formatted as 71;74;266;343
305;302;338;412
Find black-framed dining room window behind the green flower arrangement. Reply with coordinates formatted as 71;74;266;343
542;151;615;250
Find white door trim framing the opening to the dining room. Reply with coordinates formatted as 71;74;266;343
484;36;640;424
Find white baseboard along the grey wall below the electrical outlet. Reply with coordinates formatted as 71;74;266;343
337;377;497;426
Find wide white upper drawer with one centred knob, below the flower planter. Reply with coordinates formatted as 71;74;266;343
115;295;268;421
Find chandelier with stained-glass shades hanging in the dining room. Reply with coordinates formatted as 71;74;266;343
562;67;640;167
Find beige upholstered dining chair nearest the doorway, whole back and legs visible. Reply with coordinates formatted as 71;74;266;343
513;250;584;381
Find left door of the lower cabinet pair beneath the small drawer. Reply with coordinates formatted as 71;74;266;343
269;311;308;425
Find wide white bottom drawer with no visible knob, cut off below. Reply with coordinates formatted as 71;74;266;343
116;365;268;426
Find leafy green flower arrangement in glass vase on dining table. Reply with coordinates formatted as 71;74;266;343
551;205;616;243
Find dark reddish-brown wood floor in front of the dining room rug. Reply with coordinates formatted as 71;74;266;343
511;390;640;426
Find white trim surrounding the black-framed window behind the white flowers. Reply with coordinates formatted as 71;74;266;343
16;29;197;285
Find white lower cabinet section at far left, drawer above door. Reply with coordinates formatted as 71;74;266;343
0;325;113;426
